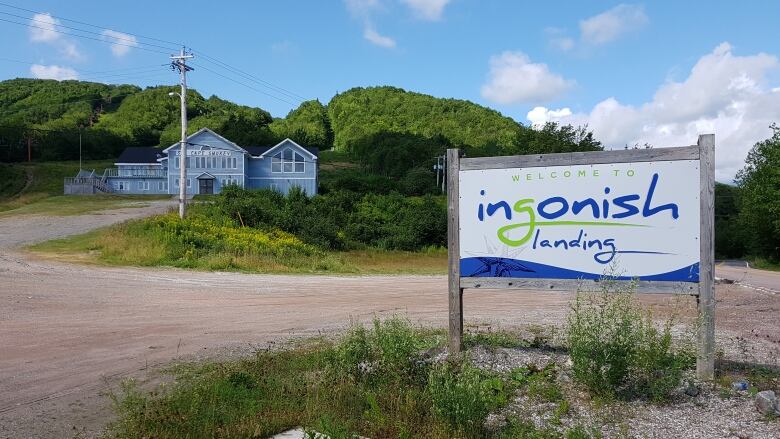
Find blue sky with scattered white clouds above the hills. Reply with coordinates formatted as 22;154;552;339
0;0;780;180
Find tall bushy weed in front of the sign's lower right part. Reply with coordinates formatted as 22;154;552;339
567;280;692;401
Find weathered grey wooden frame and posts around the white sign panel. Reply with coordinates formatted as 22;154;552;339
446;134;715;380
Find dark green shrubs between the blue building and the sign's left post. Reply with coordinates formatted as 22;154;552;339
215;187;447;250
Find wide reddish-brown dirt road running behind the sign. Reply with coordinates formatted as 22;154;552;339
0;203;780;437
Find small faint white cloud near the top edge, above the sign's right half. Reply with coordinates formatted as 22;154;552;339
580;4;648;44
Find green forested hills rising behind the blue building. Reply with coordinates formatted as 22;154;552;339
0;79;600;161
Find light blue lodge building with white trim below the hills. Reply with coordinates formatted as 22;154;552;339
70;128;319;195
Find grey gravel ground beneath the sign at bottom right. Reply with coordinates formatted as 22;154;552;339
470;348;780;439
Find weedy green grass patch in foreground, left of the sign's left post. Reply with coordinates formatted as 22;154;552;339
105;317;510;439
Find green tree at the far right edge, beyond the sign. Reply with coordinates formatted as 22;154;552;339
736;124;780;262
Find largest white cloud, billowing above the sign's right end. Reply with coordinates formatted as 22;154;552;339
528;43;780;181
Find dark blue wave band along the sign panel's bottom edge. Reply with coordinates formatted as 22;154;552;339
460;256;699;282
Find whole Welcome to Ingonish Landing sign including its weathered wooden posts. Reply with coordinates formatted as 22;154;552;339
446;135;715;380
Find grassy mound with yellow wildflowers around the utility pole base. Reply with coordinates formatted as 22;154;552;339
28;210;447;274
